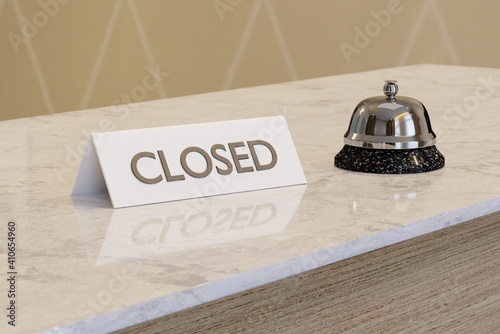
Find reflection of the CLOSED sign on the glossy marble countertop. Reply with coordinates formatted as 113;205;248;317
73;185;306;265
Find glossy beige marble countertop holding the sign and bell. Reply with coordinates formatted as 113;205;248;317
0;65;500;333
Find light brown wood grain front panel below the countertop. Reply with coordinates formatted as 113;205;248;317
117;212;500;334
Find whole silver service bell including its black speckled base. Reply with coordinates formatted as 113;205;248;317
334;80;445;174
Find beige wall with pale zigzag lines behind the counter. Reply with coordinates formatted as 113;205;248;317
0;0;500;120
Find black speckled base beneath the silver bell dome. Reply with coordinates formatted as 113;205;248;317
335;145;444;174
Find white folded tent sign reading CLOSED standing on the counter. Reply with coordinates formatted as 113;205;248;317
73;116;306;208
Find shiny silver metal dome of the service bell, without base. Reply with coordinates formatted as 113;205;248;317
344;80;436;149
